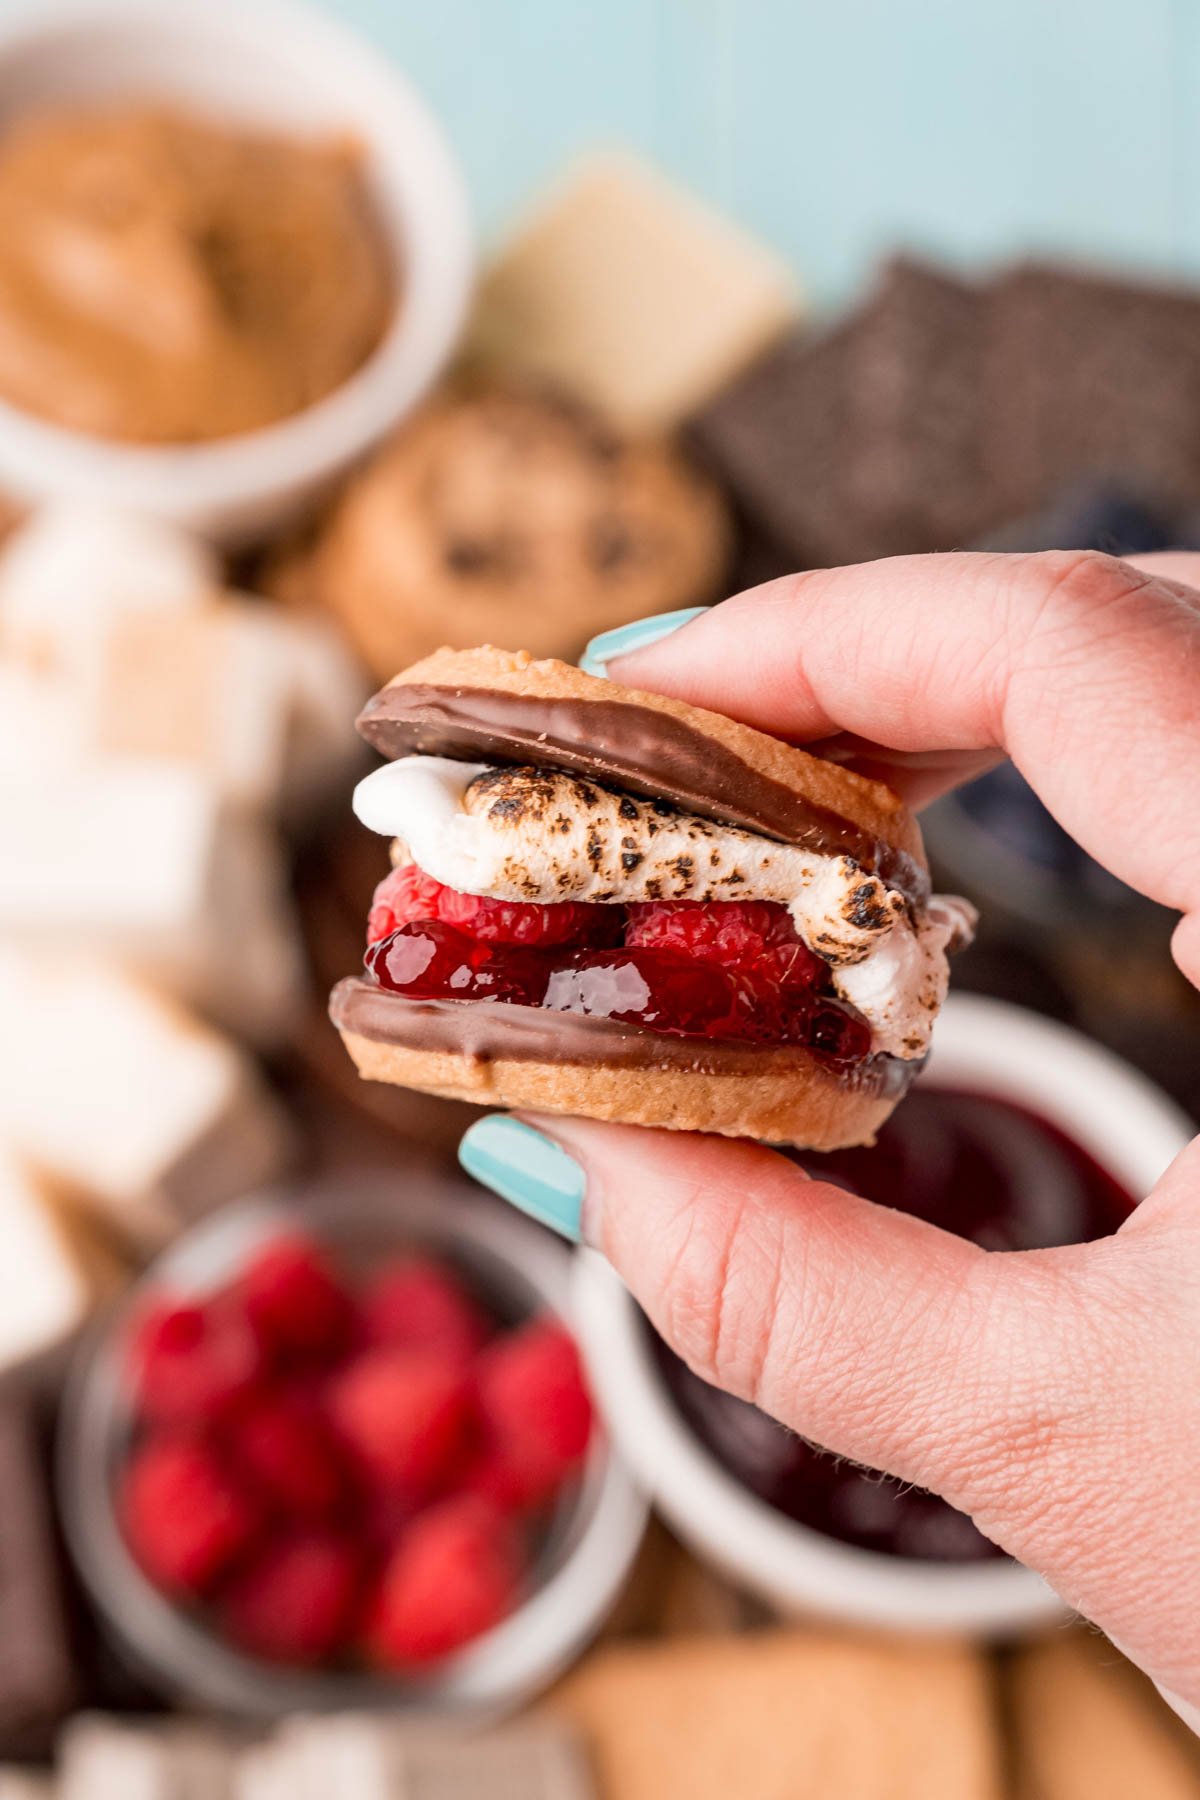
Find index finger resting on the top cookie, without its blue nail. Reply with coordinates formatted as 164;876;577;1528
610;551;1200;936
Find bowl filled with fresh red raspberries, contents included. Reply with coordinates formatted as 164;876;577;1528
59;1174;646;1715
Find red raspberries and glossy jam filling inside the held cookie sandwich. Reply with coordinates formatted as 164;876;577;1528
365;885;871;1062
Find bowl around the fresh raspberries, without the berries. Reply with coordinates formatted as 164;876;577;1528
58;1172;648;1719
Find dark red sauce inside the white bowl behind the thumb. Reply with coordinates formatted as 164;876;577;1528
658;1085;1133;1562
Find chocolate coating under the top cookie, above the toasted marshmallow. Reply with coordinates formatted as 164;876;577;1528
358;686;928;900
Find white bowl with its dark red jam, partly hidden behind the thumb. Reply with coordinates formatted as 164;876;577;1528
576;995;1191;1636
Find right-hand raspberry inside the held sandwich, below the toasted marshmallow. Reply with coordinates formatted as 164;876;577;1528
624;900;824;986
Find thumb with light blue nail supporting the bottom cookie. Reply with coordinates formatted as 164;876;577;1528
461;1116;1200;1701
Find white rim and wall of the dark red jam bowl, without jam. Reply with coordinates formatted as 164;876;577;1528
572;995;1191;1638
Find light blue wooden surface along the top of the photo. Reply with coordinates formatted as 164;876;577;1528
326;0;1200;302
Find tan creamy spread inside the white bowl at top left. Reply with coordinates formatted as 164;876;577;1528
0;106;394;443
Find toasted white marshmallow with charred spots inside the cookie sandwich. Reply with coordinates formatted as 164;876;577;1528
354;756;975;1058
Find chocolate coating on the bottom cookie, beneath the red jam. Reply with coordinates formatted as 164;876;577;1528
329;977;919;1094
